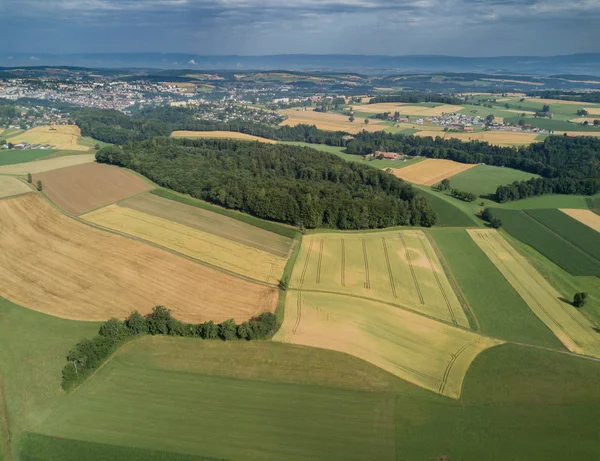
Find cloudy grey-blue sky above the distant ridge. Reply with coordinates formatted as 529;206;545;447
0;0;600;56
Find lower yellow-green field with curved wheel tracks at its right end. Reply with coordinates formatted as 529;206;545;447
273;291;501;399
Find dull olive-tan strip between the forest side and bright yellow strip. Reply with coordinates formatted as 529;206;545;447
119;193;292;258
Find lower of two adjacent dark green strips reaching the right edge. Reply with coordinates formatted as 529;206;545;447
492;208;600;276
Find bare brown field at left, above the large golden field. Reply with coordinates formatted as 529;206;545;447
33;163;154;215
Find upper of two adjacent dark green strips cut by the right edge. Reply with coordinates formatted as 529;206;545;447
526;209;600;262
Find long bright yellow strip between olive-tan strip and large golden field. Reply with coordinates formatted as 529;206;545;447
82;205;286;284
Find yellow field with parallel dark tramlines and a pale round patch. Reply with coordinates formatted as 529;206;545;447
290;230;469;328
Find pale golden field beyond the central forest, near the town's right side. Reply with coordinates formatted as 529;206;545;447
280;106;387;133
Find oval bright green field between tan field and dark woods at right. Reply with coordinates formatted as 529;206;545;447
450;165;539;195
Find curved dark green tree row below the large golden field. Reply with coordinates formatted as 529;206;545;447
62;306;279;391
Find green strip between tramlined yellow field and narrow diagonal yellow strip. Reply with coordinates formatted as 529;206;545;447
428;229;562;349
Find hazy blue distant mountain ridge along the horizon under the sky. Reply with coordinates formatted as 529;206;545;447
0;52;600;76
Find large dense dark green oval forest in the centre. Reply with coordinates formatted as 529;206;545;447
96;138;436;229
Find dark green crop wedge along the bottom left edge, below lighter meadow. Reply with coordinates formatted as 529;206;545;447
19;432;225;461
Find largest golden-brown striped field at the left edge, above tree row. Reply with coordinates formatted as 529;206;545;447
0;194;277;322
